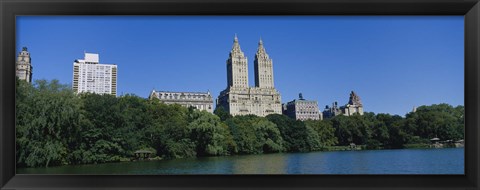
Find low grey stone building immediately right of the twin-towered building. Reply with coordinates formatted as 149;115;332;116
283;93;322;121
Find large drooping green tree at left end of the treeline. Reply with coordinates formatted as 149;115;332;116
16;80;82;167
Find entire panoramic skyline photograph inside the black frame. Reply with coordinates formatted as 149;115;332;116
15;16;465;175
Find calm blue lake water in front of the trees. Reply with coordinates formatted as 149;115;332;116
17;148;465;175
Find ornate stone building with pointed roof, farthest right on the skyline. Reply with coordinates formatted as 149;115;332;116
323;91;363;118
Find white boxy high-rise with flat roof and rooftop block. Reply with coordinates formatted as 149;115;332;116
73;53;117;96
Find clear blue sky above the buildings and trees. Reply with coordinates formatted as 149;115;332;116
17;16;464;116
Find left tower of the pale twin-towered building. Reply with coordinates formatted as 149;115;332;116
227;34;248;88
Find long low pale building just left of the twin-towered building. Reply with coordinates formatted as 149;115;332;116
148;90;213;113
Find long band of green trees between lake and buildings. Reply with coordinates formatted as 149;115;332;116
16;80;464;167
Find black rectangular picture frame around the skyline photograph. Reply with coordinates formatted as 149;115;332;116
0;0;480;190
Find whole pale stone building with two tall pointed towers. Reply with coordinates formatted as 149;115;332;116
217;35;282;117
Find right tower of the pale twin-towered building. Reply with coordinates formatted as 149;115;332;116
254;38;274;88
